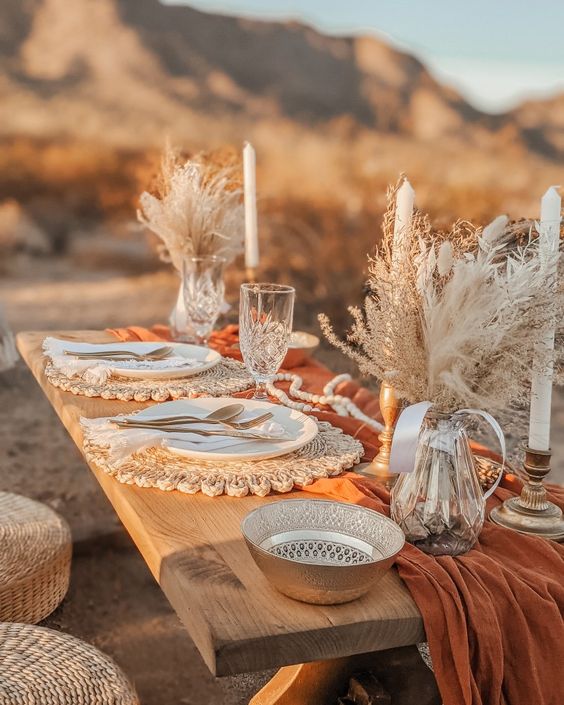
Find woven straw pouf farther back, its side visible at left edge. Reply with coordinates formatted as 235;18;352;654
0;492;72;620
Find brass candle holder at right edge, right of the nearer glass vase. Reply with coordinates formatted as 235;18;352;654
490;448;564;541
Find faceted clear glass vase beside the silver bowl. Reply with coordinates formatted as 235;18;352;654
391;411;485;556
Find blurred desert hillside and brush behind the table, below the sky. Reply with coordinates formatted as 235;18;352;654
0;0;564;328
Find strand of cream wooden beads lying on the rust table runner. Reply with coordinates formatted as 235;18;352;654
266;372;384;431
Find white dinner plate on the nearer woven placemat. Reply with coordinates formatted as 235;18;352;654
132;397;318;462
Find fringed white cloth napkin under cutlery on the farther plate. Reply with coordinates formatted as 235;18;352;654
43;338;200;384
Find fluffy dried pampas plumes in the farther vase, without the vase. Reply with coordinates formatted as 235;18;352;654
137;147;244;272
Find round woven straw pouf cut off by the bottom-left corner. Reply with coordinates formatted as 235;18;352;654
0;624;139;705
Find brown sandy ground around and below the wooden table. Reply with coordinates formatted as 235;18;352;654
0;261;564;705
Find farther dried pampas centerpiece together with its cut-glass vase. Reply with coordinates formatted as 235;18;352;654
137;147;244;339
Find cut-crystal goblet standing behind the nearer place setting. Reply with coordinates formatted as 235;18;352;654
239;284;295;400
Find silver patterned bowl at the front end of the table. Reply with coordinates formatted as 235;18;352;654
241;499;404;605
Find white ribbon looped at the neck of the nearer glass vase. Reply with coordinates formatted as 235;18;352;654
390;401;506;499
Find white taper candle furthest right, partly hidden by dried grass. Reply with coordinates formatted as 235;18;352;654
529;186;562;450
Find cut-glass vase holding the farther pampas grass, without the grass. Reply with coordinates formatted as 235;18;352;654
183;255;225;345
